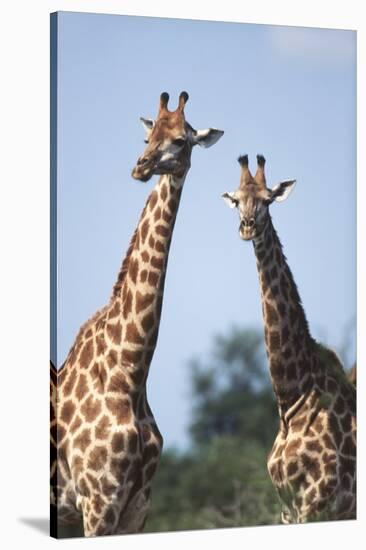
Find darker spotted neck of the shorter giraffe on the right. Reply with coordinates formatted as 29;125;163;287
253;218;313;414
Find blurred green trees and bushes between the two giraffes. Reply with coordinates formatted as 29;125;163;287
145;328;280;531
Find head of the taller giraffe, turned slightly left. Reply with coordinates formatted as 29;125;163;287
132;92;224;181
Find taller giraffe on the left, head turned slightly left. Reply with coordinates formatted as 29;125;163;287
51;92;223;536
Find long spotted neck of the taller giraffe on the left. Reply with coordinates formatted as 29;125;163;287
106;174;186;385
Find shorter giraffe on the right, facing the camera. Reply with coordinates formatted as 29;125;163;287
223;155;356;523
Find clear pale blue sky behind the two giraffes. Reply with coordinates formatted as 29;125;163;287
57;12;356;446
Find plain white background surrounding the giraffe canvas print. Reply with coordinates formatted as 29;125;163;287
0;0;366;549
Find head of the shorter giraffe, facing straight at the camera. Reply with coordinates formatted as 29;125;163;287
222;155;296;241
